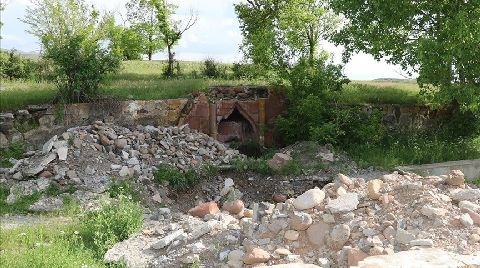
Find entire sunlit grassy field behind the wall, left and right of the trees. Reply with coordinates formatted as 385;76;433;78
0;61;419;111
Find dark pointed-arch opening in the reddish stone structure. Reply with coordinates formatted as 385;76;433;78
217;107;256;143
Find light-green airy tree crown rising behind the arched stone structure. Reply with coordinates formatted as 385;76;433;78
235;0;341;75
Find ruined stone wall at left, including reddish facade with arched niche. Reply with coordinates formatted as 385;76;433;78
0;87;286;147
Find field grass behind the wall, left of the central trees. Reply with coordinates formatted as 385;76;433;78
0;61;265;111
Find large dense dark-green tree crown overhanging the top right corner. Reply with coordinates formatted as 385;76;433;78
330;0;480;111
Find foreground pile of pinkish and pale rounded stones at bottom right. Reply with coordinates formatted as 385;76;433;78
105;171;480;268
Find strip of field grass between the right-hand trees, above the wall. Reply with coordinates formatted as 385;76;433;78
333;81;421;105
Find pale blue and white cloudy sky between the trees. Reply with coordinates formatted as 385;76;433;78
0;0;412;80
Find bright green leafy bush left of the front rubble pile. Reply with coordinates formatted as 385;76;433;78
79;196;143;258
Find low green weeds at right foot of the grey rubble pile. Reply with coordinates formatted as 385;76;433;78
154;164;200;190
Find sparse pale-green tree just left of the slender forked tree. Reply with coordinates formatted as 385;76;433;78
126;0;165;60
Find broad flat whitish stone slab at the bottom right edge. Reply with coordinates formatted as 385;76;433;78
352;248;480;268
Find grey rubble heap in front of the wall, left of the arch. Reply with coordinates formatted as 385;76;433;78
0;121;243;207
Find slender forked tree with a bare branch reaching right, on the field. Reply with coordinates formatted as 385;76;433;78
155;0;197;77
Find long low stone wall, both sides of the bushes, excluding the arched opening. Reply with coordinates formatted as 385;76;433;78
0;97;443;148
